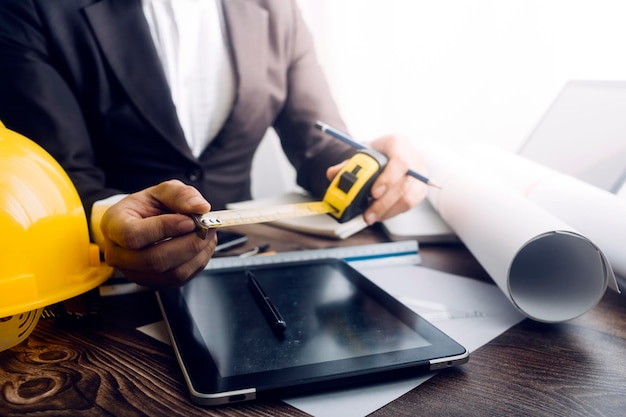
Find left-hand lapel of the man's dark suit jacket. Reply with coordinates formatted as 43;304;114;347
85;0;193;158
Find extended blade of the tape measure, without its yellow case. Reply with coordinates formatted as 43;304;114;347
192;201;337;238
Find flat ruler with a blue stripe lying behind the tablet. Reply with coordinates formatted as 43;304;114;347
205;241;421;270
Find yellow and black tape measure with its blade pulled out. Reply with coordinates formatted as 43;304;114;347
192;149;387;238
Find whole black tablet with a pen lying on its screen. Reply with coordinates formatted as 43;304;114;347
157;259;469;405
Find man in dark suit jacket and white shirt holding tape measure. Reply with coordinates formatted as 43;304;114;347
0;0;425;285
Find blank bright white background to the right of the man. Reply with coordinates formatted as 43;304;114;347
299;0;626;149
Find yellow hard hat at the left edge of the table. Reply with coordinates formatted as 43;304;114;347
0;122;113;351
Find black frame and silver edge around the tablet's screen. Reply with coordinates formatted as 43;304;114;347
157;259;469;406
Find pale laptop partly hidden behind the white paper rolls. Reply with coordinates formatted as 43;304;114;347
382;81;626;243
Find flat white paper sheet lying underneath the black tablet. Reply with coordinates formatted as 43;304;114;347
284;265;524;417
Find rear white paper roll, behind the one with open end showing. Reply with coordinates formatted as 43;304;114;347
466;143;626;277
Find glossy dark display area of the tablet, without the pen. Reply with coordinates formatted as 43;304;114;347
182;264;429;376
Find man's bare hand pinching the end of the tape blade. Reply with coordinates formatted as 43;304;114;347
101;180;217;288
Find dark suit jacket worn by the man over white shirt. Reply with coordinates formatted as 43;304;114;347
0;0;353;214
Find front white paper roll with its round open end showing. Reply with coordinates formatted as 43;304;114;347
424;146;615;322
